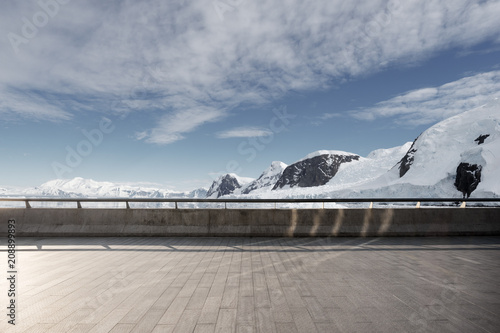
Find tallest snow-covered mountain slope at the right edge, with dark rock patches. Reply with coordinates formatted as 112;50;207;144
376;100;500;197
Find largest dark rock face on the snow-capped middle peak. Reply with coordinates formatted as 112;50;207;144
273;154;359;190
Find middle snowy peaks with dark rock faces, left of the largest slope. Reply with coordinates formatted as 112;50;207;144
202;147;411;198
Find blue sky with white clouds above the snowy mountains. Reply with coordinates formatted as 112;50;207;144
0;0;500;190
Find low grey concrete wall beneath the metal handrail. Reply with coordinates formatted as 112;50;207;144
0;208;500;237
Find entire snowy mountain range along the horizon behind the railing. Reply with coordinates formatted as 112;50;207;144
0;100;500;198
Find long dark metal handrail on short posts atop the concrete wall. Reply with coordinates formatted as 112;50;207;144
0;197;500;209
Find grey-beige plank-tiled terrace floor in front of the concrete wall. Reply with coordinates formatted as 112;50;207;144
0;237;500;333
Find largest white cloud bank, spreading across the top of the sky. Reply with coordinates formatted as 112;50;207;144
0;0;500;139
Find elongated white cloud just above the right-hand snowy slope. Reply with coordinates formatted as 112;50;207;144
351;71;500;125
